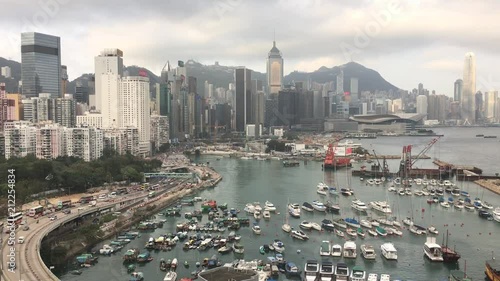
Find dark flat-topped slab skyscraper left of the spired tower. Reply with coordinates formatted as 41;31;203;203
234;67;252;132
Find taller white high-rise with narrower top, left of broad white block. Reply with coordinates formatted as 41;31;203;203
91;49;123;111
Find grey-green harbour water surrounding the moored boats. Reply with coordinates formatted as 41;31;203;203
56;128;500;281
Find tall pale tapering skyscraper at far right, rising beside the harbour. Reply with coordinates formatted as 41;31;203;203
461;53;476;125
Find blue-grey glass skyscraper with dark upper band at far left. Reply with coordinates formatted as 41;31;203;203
21;32;61;98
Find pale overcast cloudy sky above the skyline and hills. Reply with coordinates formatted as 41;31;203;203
0;0;500;95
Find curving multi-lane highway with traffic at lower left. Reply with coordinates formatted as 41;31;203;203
0;181;180;281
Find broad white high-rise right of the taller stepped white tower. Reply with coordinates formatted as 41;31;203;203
119;76;151;155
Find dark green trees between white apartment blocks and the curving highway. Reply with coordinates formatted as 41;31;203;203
0;151;162;217
